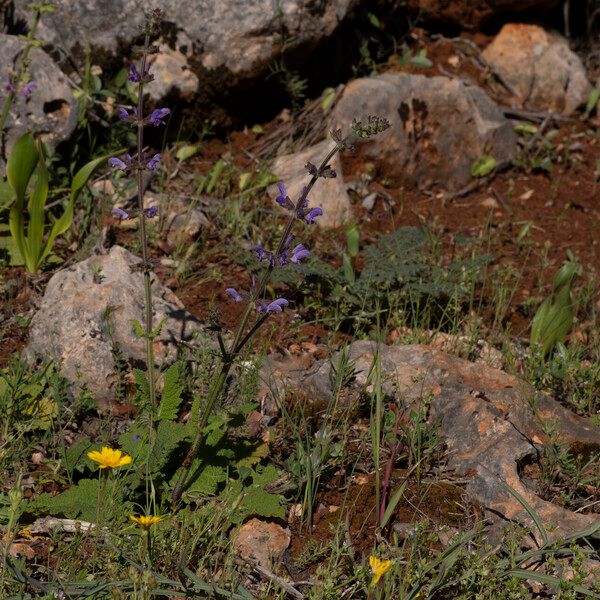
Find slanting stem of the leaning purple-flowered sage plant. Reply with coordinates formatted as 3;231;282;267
171;145;339;504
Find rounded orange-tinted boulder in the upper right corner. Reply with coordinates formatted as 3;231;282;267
483;23;592;115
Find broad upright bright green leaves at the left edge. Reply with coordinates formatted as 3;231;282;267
0;133;106;273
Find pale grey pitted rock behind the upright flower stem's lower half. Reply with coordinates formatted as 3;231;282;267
26;246;209;408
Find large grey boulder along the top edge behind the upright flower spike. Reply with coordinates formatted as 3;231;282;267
15;0;359;102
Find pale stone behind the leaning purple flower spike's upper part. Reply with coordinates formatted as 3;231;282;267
269;140;352;228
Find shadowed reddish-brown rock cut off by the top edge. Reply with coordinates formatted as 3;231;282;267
407;0;560;29
